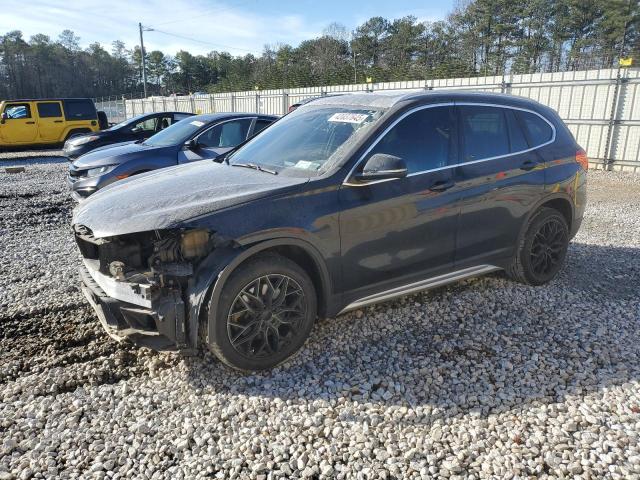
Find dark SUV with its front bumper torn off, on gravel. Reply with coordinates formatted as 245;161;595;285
73;92;588;370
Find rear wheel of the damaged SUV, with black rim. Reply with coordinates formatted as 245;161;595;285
507;207;569;285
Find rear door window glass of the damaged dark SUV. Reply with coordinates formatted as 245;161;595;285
460;105;510;162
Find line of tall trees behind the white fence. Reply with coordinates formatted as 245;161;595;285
0;0;640;99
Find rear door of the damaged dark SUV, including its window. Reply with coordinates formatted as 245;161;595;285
454;104;544;267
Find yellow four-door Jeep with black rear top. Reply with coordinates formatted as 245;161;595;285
0;98;101;149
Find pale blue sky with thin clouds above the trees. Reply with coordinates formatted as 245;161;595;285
0;0;454;55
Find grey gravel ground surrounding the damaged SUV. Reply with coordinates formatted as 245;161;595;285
0;159;640;480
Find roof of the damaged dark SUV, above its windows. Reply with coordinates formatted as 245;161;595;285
300;90;542;108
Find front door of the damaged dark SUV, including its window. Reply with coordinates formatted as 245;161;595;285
340;106;458;302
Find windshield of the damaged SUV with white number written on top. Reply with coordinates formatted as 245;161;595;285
228;105;384;176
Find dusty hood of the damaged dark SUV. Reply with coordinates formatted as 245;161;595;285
73;160;308;238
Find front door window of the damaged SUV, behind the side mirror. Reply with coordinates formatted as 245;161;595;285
370;107;454;173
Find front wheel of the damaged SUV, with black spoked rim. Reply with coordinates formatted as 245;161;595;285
203;254;317;372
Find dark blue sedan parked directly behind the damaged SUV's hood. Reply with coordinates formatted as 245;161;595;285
67;113;278;201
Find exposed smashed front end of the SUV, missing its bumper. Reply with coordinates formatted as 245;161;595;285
74;225;216;354
